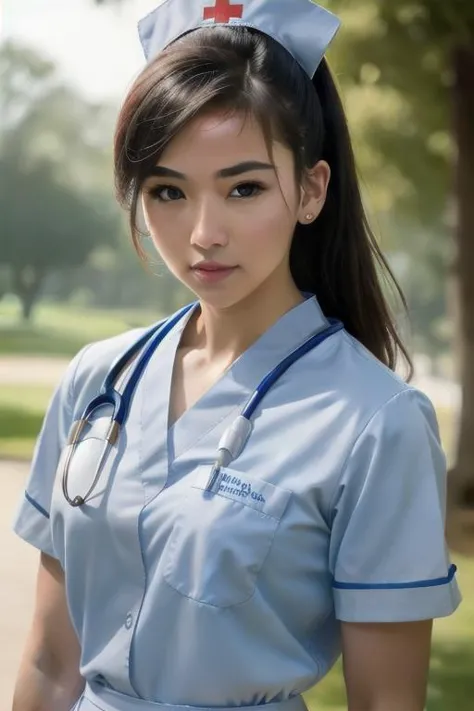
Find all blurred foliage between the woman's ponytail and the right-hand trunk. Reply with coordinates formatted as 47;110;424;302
322;0;474;354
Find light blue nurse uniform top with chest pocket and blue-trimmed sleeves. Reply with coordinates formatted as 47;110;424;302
15;297;460;711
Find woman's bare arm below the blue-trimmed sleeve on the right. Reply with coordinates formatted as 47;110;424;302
342;620;432;711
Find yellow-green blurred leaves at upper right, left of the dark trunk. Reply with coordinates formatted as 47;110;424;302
325;0;454;225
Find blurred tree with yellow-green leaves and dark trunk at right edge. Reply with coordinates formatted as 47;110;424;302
323;0;474;553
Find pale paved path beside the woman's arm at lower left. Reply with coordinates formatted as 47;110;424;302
0;462;39;711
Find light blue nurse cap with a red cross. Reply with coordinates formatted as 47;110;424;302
138;0;341;78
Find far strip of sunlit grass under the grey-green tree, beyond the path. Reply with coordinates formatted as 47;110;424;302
0;302;160;356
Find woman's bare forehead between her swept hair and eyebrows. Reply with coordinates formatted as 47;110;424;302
159;111;291;172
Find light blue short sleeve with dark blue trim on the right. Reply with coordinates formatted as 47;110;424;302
329;388;461;622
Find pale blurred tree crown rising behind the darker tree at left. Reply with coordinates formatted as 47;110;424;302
0;42;116;198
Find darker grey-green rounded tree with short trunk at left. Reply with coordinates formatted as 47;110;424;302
0;160;114;319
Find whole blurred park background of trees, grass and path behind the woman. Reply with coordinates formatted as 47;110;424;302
0;0;474;711
